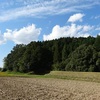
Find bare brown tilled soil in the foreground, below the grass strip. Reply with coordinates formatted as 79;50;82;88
0;77;100;100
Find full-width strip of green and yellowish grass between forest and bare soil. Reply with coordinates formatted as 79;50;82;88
0;71;100;82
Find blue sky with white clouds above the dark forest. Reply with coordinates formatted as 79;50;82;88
0;0;100;67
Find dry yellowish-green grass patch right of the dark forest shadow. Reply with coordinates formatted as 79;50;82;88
48;71;100;82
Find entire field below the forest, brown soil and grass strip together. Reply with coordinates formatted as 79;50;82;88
0;71;100;100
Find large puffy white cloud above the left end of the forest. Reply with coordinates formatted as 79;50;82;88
4;24;41;44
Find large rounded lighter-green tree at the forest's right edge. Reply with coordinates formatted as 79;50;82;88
65;45;100;71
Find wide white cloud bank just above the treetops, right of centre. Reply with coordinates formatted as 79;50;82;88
43;24;93;41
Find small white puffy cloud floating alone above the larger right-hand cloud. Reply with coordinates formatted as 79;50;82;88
68;13;84;22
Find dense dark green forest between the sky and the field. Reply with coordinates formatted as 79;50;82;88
3;35;100;74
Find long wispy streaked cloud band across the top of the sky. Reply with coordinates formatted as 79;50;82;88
0;0;100;22
